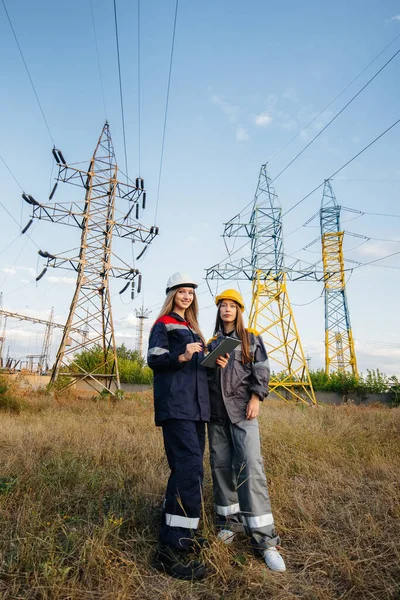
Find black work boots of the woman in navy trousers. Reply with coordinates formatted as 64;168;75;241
153;544;206;581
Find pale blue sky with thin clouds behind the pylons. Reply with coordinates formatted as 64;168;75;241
0;0;400;374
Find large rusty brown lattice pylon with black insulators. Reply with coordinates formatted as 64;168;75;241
22;123;158;394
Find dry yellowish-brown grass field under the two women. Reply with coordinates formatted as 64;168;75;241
0;382;400;600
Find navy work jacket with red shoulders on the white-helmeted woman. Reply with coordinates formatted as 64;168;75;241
147;312;210;425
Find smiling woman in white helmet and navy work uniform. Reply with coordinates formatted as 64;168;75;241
147;273;210;579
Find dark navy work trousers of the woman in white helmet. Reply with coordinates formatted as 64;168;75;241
160;419;205;550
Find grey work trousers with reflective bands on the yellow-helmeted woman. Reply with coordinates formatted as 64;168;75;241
208;419;279;551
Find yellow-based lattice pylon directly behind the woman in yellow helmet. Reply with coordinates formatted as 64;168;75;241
206;165;316;404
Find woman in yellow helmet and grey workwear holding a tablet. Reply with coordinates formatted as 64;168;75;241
208;290;286;572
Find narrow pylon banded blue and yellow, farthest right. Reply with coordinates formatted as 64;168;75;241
320;179;358;377
